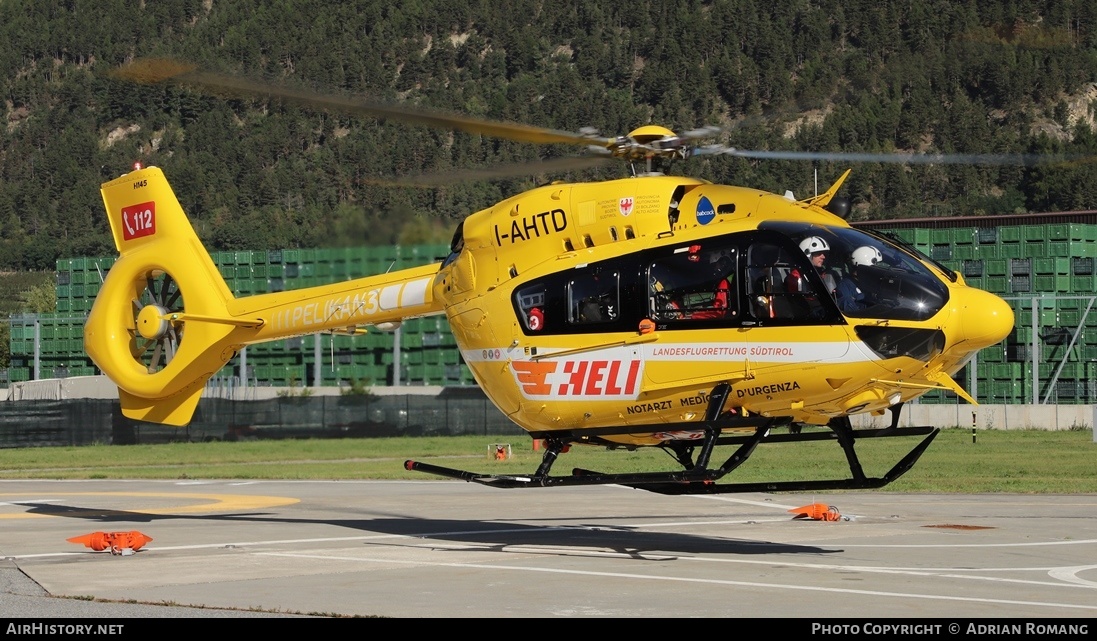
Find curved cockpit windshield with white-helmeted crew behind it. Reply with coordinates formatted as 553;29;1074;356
761;223;949;321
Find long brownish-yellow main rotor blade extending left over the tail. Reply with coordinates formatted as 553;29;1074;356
111;58;611;146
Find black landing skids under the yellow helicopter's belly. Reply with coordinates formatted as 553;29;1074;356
404;384;940;495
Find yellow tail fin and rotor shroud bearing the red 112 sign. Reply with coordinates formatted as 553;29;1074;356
84;168;241;425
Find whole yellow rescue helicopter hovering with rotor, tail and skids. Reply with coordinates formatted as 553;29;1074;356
84;60;1014;494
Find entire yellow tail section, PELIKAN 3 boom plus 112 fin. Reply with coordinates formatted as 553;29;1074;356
84;167;441;426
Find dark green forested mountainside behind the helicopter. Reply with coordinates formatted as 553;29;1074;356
0;0;1097;270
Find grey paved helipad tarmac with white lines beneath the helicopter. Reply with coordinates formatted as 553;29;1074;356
0;480;1097;619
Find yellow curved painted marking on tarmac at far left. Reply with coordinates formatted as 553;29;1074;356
0;492;301;519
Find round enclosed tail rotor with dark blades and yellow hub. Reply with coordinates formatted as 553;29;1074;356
131;270;183;374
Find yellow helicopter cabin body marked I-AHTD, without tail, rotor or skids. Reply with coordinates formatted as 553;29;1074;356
433;176;1011;445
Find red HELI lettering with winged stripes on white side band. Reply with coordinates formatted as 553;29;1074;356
510;360;643;401
